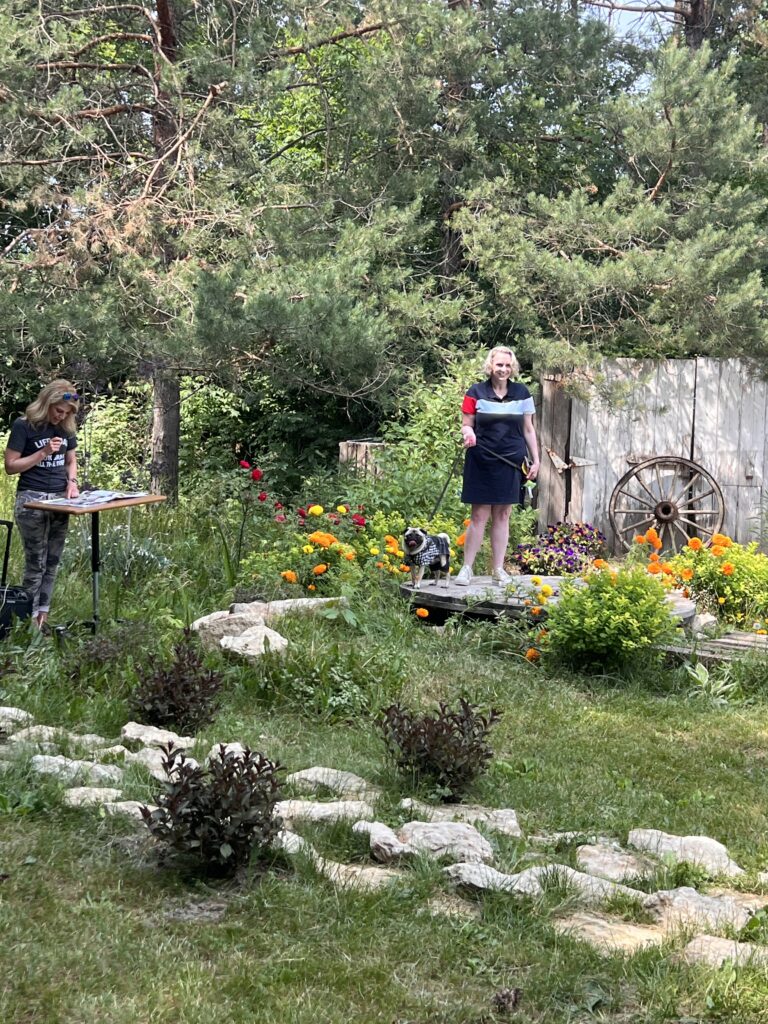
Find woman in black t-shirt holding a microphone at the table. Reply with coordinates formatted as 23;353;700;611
5;380;80;629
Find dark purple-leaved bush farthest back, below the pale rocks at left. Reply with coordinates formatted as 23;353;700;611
130;630;223;735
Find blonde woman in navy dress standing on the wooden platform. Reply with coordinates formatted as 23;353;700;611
456;347;539;587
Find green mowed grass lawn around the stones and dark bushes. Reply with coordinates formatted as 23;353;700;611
0;603;768;1024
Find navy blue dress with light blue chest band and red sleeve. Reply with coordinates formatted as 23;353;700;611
462;378;535;505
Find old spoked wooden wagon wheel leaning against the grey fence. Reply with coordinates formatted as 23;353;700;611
608;456;725;551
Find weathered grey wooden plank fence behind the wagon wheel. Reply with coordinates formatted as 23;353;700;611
538;358;768;545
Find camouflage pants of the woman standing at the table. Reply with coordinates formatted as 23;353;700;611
14;490;70;615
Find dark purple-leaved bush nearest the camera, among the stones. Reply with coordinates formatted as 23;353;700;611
141;743;283;874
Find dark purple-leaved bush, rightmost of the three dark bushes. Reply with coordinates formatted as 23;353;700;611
377;698;501;803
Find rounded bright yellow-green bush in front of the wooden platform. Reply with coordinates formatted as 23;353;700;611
545;567;675;672
